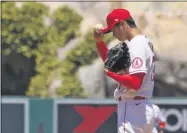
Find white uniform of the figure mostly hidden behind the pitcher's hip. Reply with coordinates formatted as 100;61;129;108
153;104;166;133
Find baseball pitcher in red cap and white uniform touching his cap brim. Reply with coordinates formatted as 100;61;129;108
93;9;155;133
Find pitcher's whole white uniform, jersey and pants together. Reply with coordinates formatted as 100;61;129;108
114;35;155;133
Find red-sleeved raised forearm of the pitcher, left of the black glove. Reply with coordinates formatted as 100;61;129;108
96;41;108;61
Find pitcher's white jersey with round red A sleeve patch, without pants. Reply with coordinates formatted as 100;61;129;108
114;35;155;98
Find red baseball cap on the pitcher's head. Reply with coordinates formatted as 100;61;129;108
102;9;131;34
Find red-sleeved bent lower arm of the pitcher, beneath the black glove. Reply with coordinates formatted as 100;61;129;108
107;71;145;90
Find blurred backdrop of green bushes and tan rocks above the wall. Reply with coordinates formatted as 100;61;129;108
1;1;187;133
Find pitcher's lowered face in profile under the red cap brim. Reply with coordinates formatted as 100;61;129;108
112;23;127;41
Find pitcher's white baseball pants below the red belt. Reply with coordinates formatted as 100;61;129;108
117;99;154;133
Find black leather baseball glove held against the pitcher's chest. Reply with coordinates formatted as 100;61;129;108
104;42;131;73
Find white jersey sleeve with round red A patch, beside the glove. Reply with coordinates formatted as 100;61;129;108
129;45;147;74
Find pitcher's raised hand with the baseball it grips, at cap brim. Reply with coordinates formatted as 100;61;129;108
93;24;103;42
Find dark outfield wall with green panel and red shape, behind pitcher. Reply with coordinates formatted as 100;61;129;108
1;97;187;133
